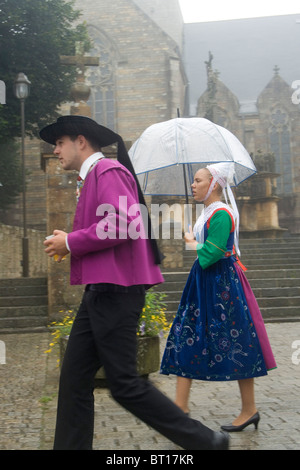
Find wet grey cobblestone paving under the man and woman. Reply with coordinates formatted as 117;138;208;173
0;323;300;451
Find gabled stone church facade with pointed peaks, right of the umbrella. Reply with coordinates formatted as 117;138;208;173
197;63;300;234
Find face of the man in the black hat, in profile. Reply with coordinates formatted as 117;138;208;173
53;136;81;171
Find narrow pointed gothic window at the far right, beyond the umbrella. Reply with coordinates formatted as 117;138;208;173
270;109;293;195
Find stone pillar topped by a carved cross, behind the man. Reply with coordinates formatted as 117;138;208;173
41;43;99;321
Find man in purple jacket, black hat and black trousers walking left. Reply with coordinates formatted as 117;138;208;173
40;116;228;450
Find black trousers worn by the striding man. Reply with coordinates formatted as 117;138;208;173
54;289;214;450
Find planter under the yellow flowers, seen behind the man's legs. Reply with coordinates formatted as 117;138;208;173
60;336;160;386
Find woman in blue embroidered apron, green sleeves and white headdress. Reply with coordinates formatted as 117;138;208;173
161;163;276;432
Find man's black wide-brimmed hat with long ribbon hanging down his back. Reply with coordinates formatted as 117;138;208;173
40;115;163;264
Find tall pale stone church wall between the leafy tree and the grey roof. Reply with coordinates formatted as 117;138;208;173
77;0;187;142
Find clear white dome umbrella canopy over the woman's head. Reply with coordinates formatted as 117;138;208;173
129;118;256;196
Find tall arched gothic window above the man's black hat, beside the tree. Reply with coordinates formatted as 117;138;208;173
86;26;116;130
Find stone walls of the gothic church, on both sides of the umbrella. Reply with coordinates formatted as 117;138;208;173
0;0;300;239
